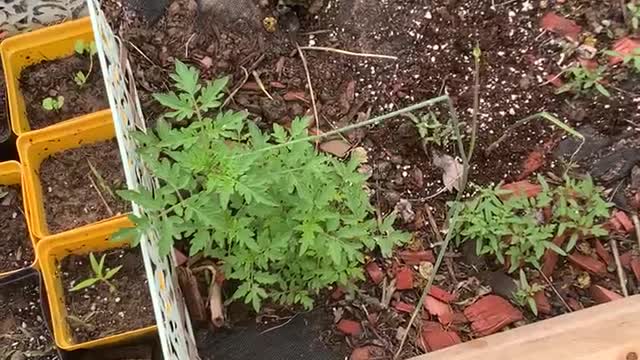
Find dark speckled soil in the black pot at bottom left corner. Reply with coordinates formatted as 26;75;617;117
0;277;58;360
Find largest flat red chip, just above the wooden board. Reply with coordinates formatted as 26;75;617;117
464;295;524;336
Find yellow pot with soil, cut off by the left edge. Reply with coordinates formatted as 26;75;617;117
0;161;36;277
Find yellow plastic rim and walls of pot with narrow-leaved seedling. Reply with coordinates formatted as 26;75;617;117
37;217;157;351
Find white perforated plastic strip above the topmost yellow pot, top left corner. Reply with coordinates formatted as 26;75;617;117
0;0;87;35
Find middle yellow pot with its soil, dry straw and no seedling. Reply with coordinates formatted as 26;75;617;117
17;110;130;239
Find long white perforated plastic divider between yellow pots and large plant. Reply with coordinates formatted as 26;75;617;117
87;0;199;360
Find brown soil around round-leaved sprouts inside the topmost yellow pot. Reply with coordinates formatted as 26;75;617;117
20;55;109;130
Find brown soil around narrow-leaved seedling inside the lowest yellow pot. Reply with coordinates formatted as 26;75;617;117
59;249;155;342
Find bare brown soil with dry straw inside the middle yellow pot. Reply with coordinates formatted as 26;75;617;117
40;139;130;234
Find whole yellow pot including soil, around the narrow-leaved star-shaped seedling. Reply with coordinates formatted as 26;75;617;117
37;218;156;351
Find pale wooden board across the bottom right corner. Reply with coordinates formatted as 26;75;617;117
411;295;640;360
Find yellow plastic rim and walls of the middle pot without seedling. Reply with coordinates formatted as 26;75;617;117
17;110;124;240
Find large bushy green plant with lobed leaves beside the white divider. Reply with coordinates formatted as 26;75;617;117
116;61;409;311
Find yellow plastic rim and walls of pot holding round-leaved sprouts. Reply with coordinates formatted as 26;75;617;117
0;17;94;135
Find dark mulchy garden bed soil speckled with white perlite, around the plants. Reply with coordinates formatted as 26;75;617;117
103;0;640;358
